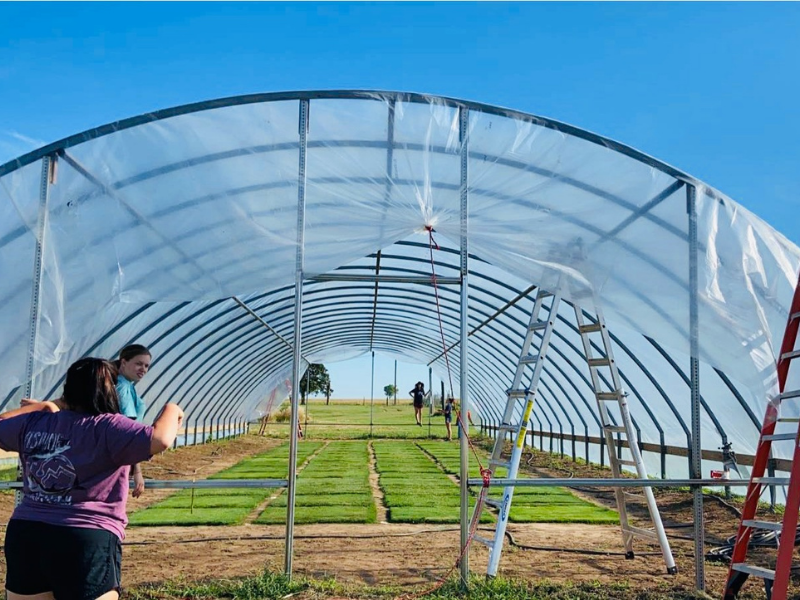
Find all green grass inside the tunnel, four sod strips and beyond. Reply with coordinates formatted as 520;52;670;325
130;402;618;526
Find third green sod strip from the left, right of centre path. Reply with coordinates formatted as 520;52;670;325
372;441;491;523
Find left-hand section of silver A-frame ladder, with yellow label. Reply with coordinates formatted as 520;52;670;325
470;288;561;577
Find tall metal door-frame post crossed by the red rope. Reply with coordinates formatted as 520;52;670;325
458;106;469;587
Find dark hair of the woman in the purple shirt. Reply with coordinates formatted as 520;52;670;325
64;358;119;415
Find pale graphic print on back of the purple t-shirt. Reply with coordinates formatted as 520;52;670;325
24;431;76;504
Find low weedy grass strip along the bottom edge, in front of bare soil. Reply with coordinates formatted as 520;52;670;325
126;571;720;600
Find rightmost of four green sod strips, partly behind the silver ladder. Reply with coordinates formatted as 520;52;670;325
418;441;619;524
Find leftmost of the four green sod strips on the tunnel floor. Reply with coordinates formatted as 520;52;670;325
130;442;322;526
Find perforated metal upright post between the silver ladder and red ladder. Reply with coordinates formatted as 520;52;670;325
686;185;706;590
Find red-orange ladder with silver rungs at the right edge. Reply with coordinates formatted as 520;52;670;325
724;274;800;600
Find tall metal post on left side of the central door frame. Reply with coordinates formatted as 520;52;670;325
284;100;309;578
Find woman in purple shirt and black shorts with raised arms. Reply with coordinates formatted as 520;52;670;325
0;358;183;600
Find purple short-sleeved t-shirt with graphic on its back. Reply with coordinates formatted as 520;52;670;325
0;410;153;539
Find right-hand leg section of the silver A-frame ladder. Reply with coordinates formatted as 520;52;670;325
574;302;678;575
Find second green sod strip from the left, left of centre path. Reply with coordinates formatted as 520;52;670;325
256;441;377;524
